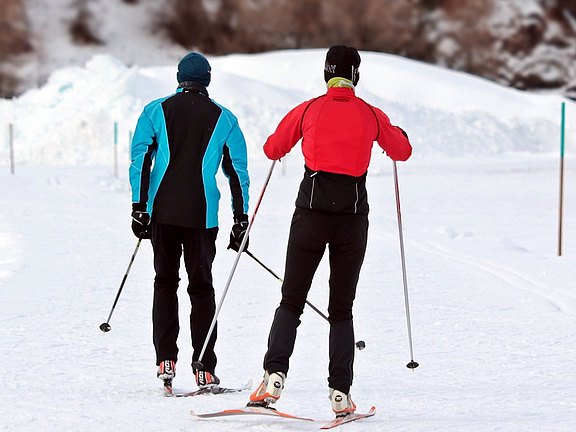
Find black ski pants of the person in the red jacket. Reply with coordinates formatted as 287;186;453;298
264;209;368;394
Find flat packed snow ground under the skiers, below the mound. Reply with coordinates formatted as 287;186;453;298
0;157;576;431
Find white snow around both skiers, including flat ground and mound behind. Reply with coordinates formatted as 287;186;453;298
0;50;576;432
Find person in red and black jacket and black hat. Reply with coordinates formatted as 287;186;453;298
250;45;412;416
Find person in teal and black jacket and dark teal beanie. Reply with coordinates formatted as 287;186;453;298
129;52;250;388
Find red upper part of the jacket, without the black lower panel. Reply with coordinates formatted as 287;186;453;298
264;88;412;177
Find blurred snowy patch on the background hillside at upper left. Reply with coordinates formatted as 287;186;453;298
26;0;185;82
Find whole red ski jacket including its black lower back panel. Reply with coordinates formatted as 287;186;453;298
264;87;412;214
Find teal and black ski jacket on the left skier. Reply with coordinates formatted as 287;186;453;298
129;83;250;228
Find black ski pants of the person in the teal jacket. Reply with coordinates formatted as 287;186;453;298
152;223;218;373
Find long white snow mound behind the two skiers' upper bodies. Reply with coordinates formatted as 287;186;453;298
0;50;561;165
